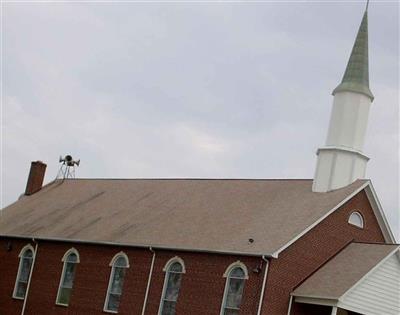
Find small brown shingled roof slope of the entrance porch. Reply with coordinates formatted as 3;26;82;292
292;243;399;300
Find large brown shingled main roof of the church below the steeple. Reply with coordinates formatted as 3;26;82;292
0;179;366;255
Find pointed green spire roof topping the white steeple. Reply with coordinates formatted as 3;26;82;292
332;10;374;101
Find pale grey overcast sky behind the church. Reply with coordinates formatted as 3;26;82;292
1;1;399;239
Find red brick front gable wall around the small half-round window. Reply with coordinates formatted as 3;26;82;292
263;191;384;315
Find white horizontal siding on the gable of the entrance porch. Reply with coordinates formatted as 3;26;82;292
339;254;400;315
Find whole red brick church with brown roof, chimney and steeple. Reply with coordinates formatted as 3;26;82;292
0;4;400;315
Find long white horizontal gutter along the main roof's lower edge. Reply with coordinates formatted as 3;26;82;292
0;234;278;258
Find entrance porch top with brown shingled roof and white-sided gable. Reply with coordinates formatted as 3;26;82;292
292;243;400;315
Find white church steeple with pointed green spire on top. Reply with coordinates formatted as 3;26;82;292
312;9;374;192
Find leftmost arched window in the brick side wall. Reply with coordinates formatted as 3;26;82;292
13;244;34;299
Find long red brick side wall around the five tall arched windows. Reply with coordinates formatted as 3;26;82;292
0;239;263;315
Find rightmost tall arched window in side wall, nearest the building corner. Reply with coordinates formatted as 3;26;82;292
221;261;248;315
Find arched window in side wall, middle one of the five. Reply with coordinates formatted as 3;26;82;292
104;252;129;313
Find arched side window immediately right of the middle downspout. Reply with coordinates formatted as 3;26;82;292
158;257;185;315
